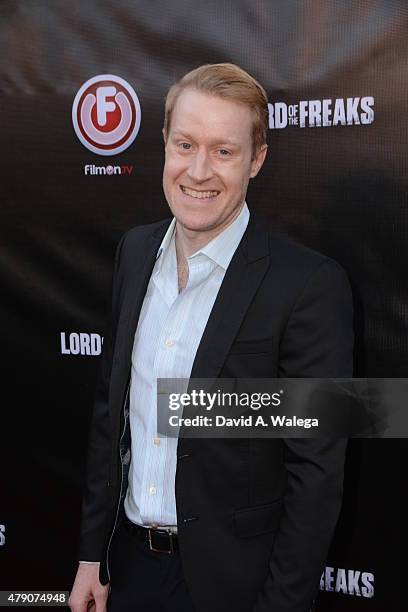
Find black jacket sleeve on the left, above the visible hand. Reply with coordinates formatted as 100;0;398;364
78;234;126;561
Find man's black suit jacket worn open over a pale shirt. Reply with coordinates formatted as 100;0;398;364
79;214;353;612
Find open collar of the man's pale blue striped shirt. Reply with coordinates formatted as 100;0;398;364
156;201;249;270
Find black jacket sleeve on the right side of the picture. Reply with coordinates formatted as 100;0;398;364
253;259;353;612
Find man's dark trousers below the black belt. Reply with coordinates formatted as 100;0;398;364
107;523;194;612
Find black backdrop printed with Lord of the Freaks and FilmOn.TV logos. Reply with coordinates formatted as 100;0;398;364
0;0;408;612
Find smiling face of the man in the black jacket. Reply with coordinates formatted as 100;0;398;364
163;89;267;233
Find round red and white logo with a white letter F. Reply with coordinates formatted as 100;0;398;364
72;74;141;157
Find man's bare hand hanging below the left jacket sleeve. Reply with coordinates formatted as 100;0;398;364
68;563;109;612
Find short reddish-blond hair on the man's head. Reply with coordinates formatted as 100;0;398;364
163;63;269;159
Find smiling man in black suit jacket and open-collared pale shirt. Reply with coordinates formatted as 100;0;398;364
70;64;353;612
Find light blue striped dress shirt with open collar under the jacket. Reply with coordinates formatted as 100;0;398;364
125;202;249;526
